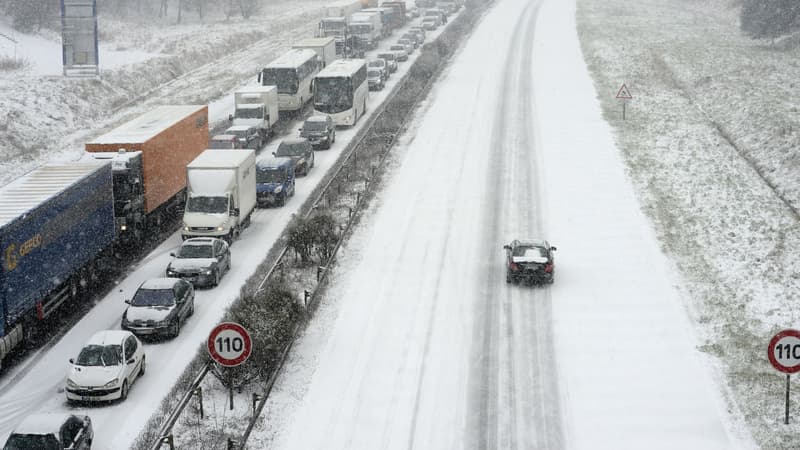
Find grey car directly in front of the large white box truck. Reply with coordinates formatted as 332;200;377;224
167;237;231;286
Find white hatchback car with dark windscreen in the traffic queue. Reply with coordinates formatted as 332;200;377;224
66;330;145;402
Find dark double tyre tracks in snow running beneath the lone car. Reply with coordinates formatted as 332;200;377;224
467;2;563;449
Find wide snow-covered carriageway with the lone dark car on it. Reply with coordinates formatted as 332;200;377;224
254;0;748;449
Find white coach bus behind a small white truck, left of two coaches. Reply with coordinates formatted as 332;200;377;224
258;49;320;111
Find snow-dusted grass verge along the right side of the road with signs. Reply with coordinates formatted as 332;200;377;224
577;0;800;448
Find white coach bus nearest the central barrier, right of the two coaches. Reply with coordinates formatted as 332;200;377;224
314;59;369;125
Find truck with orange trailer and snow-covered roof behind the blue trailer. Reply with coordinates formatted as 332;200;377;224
85;105;208;245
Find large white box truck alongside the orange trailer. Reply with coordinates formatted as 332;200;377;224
181;150;256;242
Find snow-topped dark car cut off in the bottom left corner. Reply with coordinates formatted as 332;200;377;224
3;413;94;450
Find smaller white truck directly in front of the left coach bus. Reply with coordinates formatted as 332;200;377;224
229;86;278;140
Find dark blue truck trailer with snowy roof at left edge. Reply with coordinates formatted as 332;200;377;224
0;160;114;361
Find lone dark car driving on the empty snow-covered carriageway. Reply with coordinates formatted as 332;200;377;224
503;239;556;284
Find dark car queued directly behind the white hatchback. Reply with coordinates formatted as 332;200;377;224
122;278;194;337
